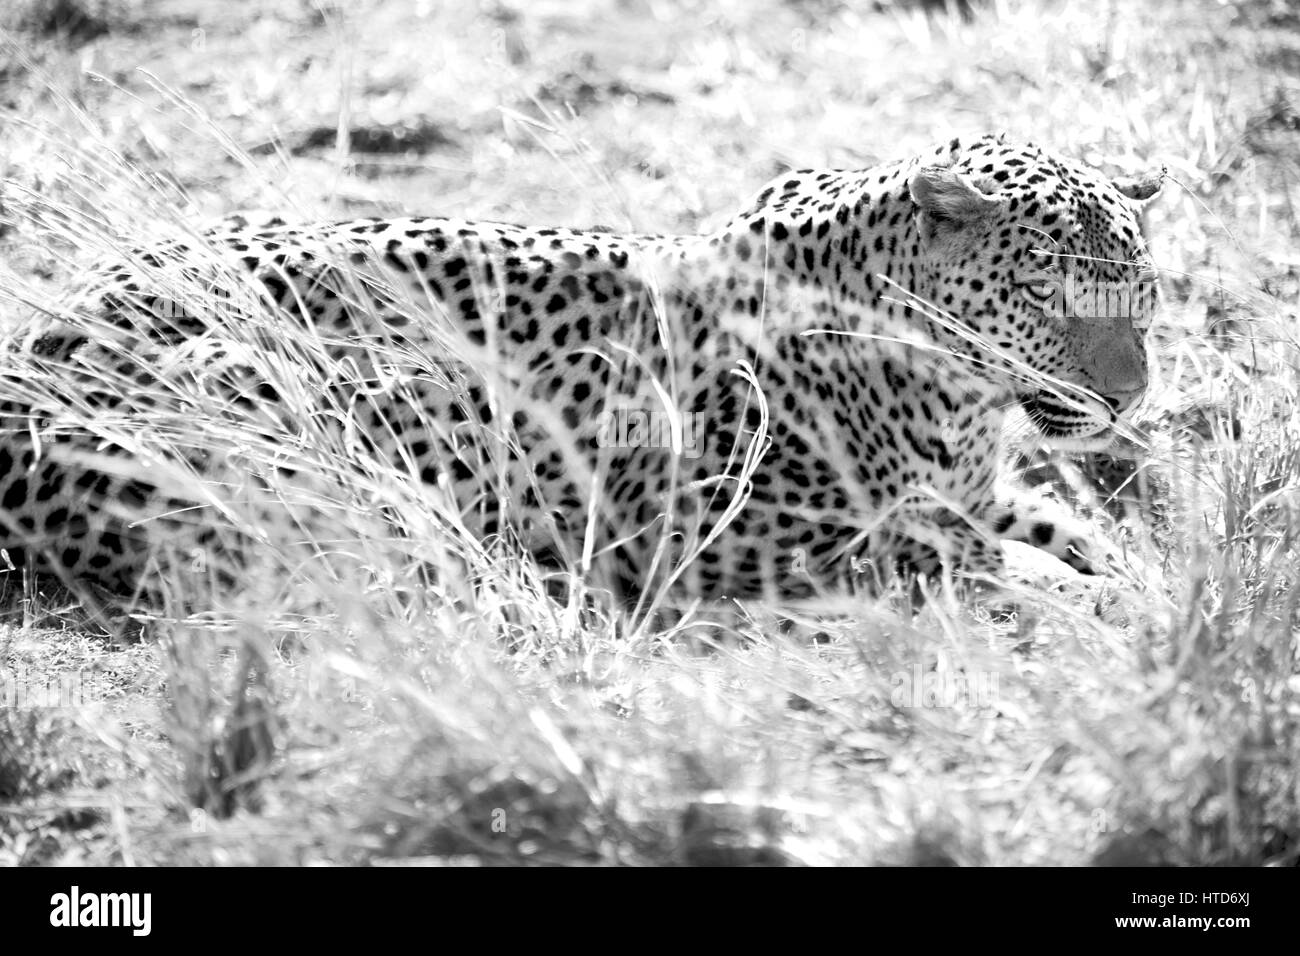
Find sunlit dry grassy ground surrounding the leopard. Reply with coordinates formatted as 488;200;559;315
0;0;1300;864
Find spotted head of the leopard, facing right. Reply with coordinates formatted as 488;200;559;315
909;137;1164;449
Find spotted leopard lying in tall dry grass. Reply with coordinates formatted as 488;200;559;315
0;134;1165;600
